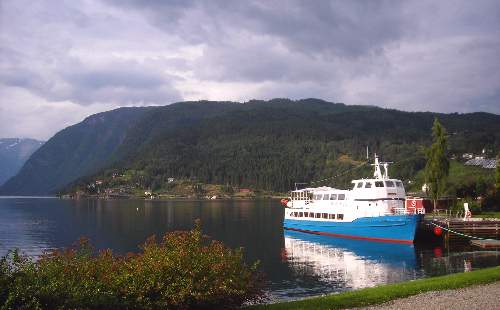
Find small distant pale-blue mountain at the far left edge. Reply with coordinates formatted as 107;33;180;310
0;138;43;185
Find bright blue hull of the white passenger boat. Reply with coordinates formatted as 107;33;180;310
283;215;423;243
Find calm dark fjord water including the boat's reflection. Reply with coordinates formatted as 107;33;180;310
0;197;500;301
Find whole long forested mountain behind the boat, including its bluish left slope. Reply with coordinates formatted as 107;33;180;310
0;99;500;194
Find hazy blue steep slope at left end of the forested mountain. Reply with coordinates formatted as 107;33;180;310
0;108;152;195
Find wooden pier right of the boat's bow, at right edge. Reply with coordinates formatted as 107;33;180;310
425;217;500;241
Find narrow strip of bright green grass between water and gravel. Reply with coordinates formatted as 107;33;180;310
255;266;500;309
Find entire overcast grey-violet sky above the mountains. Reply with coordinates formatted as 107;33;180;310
0;0;500;139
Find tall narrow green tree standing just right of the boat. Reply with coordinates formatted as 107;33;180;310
425;118;450;211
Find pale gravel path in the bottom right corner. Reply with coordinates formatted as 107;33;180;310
357;282;500;310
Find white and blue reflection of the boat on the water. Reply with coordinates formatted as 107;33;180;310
283;230;417;291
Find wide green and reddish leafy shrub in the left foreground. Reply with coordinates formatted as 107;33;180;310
0;223;262;309
